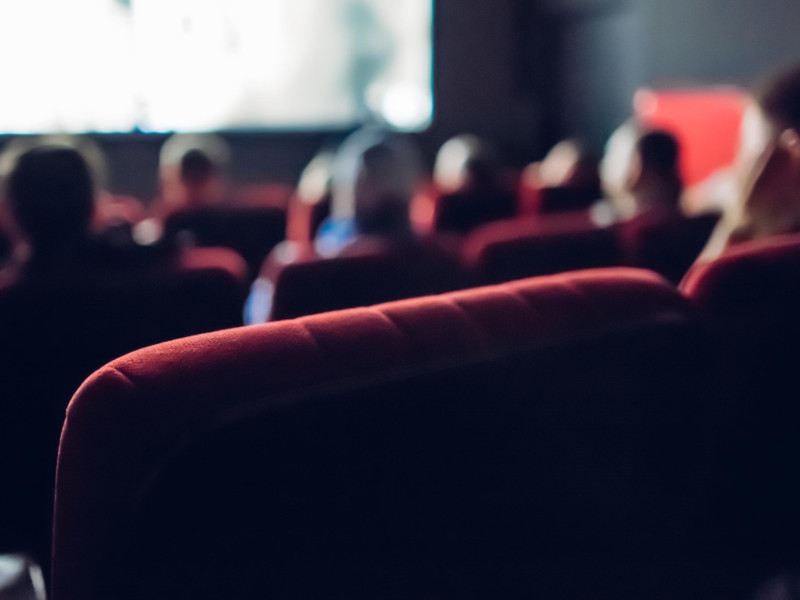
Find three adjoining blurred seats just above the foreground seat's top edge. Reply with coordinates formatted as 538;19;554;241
261;213;717;320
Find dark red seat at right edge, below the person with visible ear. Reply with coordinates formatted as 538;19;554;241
681;236;800;592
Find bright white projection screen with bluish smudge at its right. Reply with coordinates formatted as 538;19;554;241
0;0;432;133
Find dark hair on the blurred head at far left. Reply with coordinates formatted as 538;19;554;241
5;145;95;247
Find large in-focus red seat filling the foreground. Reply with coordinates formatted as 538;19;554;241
52;269;708;600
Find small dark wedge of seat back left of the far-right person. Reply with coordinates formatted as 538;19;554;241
617;214;719;284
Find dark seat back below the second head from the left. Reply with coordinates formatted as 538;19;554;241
164;206;286;276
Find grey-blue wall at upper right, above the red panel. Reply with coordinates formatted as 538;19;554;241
541;0;800;149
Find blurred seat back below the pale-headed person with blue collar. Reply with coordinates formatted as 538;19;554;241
262;239;461;321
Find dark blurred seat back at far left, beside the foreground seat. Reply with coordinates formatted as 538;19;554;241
0;249;245;564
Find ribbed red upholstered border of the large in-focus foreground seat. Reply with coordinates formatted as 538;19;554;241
53;269;686;600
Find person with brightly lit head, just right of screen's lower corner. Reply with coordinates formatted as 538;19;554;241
433;135;517;234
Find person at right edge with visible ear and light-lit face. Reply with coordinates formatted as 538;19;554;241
702;66;800;260
